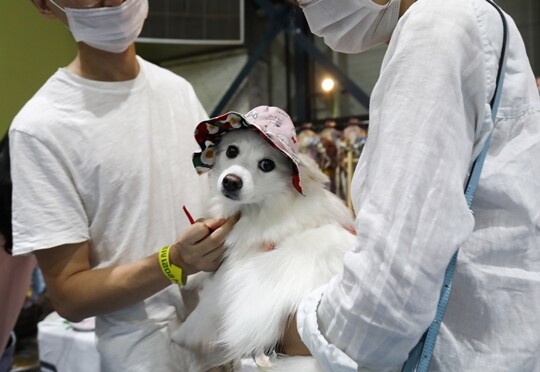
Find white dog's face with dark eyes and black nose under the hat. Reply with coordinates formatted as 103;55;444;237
210;129;297;211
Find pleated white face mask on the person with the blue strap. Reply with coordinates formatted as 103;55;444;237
301;0;400;53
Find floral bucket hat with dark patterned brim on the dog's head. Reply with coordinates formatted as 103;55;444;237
193;106;302;193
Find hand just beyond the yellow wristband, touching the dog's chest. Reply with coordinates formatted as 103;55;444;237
169;217;238;276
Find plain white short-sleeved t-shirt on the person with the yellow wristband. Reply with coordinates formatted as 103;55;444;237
10;58;207;372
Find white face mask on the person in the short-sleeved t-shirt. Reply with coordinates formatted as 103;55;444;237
50;0;148;53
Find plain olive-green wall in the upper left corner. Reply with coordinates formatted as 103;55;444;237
0;0;76;136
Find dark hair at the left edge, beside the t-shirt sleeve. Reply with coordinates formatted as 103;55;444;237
0;134;13;254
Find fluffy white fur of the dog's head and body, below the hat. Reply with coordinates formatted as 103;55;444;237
172;129;355;371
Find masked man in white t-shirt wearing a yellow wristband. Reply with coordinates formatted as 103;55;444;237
10;0;234;372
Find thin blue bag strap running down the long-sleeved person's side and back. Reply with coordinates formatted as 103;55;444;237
401;0;508;372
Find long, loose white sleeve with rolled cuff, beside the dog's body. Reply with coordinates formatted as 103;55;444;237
298;0;491;371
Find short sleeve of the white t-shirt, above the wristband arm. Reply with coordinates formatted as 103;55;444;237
9;130;89;254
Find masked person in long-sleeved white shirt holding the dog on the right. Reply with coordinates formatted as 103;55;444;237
284;0;540;372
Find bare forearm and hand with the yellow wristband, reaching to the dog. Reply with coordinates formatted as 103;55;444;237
35;218;235;321
